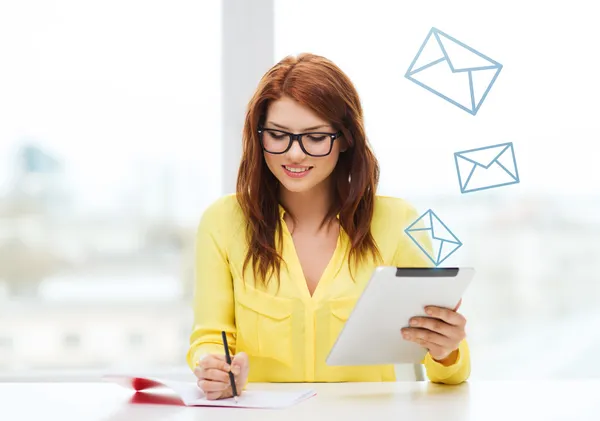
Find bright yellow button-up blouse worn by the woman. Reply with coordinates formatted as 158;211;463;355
187;194;470;384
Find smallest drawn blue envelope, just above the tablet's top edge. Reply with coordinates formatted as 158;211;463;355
404;209;462;266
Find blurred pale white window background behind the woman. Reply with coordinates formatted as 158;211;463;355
0;0;600;379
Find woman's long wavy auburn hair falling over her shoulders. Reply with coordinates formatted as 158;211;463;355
236;53;380;285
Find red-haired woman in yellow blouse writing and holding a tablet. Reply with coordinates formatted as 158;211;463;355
187;54;470;399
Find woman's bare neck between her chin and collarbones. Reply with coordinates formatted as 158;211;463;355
279;177;333;230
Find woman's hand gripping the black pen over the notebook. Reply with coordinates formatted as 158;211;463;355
194;352;250;400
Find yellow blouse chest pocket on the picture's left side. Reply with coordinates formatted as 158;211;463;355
235;286;293;365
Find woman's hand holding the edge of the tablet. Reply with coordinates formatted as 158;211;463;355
402;300;467;361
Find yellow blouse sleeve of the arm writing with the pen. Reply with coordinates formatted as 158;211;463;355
186;205;235;370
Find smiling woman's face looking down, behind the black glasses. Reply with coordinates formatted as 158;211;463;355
263;96;342;193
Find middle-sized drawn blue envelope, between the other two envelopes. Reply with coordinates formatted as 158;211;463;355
454;142;520;193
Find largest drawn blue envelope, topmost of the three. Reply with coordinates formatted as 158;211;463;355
404;28;502;115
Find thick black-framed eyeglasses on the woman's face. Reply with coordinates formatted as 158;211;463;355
258;127;342;157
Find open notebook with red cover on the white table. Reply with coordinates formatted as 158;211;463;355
102;375;316;409
